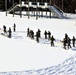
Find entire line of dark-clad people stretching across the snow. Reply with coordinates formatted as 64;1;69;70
3;23;76;49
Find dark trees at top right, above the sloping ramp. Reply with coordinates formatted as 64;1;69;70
52;0;76;13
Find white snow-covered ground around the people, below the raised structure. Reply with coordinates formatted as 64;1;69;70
0;12;76;75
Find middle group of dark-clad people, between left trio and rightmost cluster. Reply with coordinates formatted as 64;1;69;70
27;28;55;46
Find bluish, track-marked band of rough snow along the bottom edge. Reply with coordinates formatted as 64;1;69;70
0;55;76;75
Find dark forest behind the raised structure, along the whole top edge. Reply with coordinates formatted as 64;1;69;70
0;0;76;13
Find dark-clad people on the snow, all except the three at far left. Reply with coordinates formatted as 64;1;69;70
27;27;76;49
